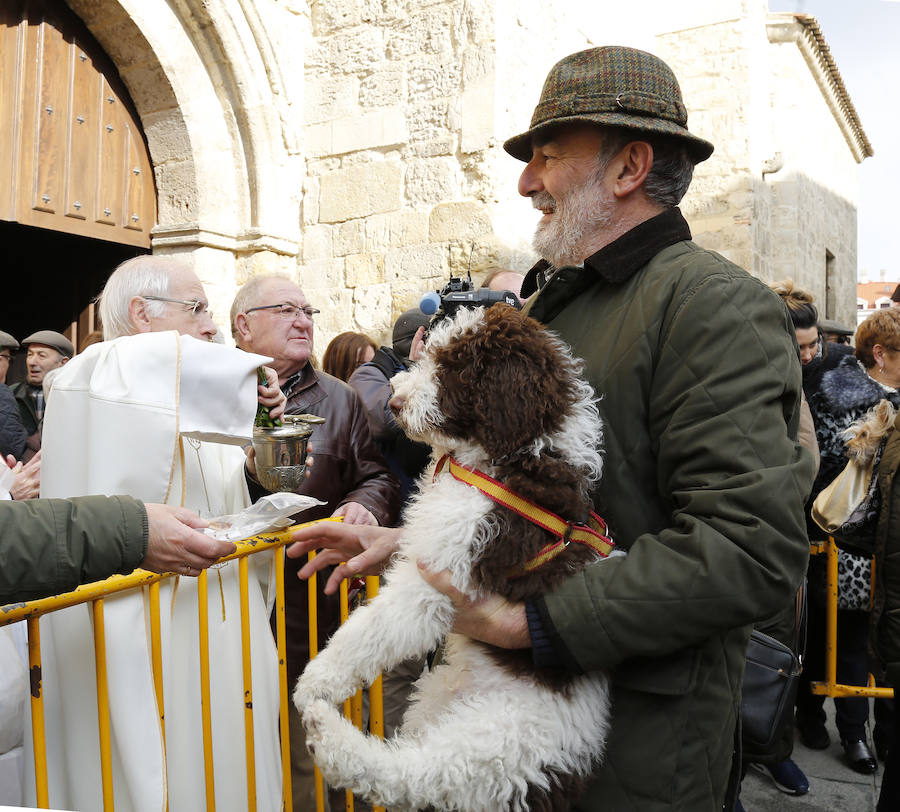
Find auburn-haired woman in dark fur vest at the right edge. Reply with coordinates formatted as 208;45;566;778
797;309;900;774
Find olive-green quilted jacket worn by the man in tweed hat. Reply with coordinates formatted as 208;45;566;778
526;209;813;812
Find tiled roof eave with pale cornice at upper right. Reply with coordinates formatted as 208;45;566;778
766;12;874;163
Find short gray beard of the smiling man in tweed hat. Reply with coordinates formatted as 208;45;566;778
531;176;616;268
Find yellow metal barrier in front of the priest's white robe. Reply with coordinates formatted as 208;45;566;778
0;520;384;812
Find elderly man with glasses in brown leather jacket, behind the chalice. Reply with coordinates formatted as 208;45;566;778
231;276;400;810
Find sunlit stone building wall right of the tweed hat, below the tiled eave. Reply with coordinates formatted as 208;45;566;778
657;0;858;323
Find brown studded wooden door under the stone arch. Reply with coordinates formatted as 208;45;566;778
0;0;156;248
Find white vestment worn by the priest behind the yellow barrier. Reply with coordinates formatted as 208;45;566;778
26;332;281;812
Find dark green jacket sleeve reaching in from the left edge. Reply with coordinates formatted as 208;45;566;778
0;496;148;604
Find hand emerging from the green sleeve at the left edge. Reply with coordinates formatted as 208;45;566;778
141;503;237;575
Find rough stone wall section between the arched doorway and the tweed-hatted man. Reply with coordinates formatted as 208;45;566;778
298;0;498;351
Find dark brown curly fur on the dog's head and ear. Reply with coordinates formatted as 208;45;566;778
436;305;574;459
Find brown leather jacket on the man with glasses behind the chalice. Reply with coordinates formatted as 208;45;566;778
250;364;400;688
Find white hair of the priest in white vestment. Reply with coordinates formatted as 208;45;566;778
100;255;185;341
